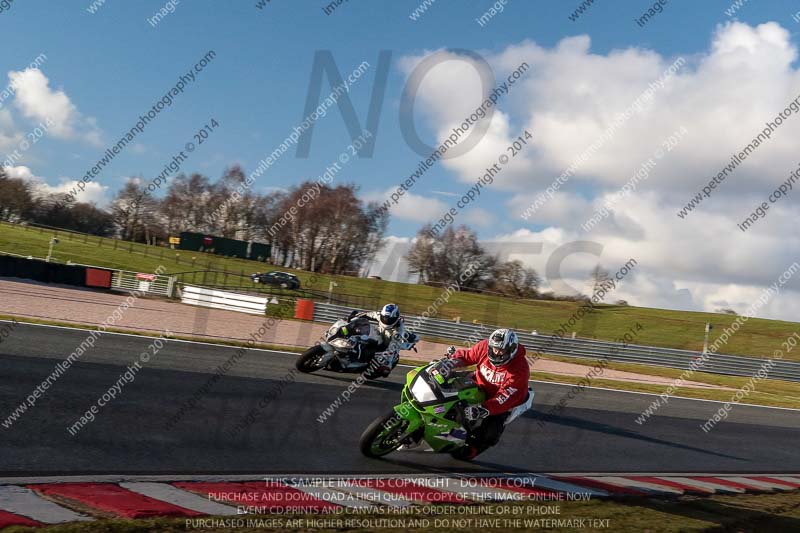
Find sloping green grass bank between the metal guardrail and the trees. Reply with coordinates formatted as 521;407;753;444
0;220;800;361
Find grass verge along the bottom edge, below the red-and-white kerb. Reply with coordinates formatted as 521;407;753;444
4;492;800;533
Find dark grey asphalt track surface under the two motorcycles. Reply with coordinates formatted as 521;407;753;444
0;324;800;476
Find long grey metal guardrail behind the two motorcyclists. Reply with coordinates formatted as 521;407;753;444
314;303;800;382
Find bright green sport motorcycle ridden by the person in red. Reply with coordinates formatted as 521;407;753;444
360;361;533;459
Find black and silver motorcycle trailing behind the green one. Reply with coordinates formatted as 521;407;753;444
295;317;419;379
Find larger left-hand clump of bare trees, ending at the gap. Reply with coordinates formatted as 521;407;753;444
0;165;389;275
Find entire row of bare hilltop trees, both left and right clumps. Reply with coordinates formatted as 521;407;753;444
0;165;626;305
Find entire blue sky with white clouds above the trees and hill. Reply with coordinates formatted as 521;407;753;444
0;0;800;320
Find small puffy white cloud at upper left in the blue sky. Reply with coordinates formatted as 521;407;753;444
8;68;102;146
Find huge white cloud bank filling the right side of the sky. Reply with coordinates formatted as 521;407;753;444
403;22;800;320
